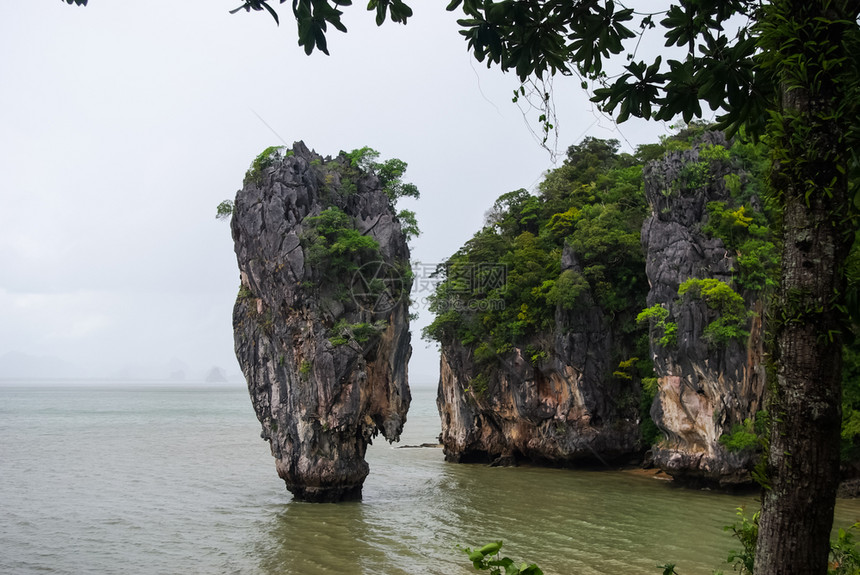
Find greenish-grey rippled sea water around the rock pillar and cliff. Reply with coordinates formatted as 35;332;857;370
0;382;860;575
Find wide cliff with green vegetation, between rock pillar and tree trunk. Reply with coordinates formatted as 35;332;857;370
434;133;778;486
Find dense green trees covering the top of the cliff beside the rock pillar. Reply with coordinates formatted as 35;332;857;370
424;138;648;353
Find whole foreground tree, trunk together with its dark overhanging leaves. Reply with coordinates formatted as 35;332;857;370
66;0;860;574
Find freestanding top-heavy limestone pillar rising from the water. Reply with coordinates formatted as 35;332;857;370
231;142;411;501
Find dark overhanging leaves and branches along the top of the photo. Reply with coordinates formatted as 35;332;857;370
218;0;860;146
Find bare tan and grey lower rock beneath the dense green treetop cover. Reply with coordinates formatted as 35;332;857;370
437;246;639;466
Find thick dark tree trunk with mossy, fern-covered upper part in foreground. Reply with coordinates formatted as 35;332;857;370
755;0;856;575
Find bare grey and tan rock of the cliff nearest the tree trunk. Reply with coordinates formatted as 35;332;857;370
642;133;765;486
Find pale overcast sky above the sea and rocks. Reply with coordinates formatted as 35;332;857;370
0;0;680;385
